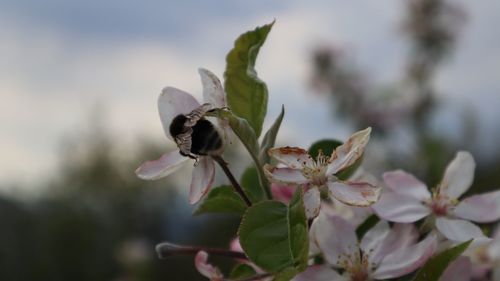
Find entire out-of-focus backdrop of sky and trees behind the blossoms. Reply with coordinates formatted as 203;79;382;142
0;0;500;281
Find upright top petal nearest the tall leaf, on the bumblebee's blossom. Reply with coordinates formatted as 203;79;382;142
198;68;226;108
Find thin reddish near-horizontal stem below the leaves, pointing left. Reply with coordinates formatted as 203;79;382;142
156;242;248;260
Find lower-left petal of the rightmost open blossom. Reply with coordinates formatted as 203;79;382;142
372;192;431;223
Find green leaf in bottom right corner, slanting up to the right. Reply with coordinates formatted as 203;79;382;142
413;239;472;281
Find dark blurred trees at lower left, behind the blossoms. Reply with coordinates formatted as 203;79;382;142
0;118;237;281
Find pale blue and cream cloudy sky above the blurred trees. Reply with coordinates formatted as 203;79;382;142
0;0;500;187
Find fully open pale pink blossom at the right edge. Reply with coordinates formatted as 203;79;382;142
372;151;500;242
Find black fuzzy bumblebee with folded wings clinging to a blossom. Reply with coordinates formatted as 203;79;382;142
169;103;224;160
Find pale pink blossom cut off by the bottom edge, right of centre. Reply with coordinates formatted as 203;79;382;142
294;213;437;281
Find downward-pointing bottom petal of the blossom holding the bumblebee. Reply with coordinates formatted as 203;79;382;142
189;156;215;204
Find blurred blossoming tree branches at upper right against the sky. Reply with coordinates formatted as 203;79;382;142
313;0;469;183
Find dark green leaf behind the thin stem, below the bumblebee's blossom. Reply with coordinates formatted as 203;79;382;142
194;185;247;215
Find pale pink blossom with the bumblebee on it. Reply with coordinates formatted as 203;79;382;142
135;68;226;204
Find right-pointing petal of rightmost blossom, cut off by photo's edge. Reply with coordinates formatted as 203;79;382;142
453;191;500;223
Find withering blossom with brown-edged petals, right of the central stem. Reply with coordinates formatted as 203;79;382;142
264;128;380;218
